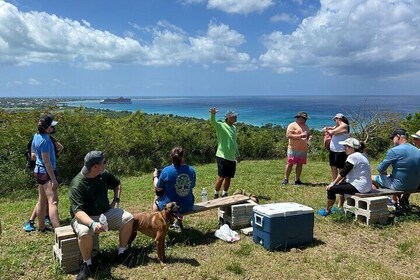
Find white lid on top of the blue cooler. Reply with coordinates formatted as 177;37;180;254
253;202;314;217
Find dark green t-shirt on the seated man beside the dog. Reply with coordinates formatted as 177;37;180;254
69;170;120;218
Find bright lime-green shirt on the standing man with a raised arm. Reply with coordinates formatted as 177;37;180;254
210;114;239;161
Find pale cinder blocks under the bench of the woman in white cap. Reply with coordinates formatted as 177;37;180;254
343;194;389;225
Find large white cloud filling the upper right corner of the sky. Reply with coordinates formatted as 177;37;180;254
260;0;420;77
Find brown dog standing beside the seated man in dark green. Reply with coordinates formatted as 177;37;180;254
128;202;179;264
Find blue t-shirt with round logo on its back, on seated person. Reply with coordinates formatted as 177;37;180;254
157;164;196;214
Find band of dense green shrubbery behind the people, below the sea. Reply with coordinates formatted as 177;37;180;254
0;108;420;195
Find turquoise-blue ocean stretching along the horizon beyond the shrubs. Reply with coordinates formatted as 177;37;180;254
65;95;420;129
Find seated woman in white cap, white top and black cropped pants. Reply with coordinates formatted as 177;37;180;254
317;138;372;217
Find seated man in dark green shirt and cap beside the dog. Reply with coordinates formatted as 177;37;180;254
69;151;133;280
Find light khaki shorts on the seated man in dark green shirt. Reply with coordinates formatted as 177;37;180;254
71;208;133;238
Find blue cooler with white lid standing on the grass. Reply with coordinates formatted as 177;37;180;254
252;202;314;251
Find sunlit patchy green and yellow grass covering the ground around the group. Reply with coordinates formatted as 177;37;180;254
0;161;420;280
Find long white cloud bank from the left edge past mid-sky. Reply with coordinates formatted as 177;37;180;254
0;1;255;71
